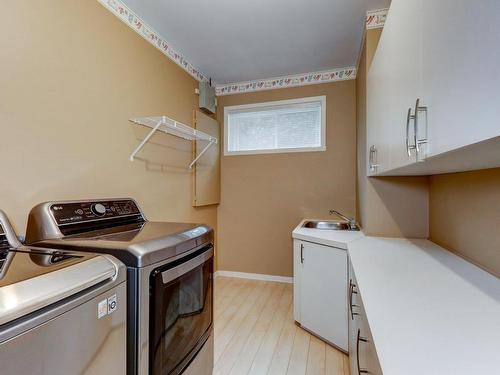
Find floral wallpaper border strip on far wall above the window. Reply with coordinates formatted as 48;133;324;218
215;67;356;96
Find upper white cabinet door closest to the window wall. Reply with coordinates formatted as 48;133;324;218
367;0;422;173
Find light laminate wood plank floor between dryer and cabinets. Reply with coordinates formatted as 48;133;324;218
214;277;349;375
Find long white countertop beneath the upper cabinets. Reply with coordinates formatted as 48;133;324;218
348;237;500;375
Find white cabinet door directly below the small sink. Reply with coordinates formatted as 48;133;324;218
300;242;348;352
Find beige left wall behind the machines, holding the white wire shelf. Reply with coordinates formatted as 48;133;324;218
0;0;216;238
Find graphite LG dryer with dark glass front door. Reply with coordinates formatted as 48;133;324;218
26;199;214;375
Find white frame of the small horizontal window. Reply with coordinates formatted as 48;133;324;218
224;95;326;156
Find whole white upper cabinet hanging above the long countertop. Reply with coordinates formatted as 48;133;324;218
367;0;500;175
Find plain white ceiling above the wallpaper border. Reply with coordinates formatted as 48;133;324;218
122;0;390;84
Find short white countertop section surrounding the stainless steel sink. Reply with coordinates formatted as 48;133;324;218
292;219;364;250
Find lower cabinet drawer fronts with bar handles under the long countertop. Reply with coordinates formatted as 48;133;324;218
348;262;382;375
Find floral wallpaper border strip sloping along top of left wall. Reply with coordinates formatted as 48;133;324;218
97;0;208;81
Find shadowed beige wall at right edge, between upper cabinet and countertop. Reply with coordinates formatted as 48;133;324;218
430;168;500;277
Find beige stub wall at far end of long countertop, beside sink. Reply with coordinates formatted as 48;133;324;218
356;29;429;238
